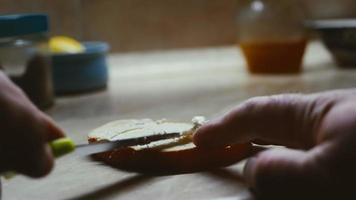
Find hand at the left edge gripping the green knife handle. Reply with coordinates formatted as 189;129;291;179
0;71;64;177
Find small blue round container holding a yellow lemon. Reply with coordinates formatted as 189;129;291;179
52;42;109;94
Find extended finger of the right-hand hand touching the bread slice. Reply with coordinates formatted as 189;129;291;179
194;95;331;149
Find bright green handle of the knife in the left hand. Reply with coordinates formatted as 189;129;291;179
1;137;75;179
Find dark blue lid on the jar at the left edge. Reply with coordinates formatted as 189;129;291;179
0;14;49;38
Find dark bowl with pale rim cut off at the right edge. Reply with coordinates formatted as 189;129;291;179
307;19;356;68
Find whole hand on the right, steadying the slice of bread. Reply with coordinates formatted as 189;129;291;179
194;90;356;199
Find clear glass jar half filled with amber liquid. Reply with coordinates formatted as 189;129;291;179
237;0;307;73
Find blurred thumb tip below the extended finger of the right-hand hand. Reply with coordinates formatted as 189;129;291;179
244;147;329;199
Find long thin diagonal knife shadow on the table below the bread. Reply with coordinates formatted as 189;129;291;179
70;175;152;200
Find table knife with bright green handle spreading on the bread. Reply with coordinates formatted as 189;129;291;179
1;132;185;179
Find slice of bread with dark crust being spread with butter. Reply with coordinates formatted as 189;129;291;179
88;117;251;175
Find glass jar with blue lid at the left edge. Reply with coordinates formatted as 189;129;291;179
0;14;54;109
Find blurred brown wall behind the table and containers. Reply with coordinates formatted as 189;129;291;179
0;0;356;52
